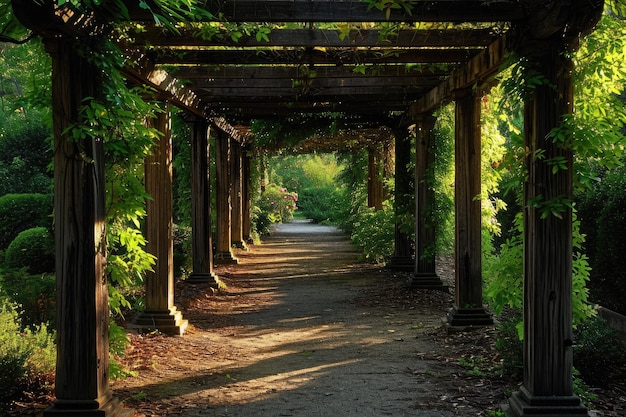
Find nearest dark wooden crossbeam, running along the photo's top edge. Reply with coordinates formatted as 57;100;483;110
126;0;525;23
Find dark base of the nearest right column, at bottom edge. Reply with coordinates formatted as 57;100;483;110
503;386;593;417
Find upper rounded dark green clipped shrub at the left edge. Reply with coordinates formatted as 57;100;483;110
0;194;52;248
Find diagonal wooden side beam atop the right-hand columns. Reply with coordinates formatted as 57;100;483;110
410;36;507;115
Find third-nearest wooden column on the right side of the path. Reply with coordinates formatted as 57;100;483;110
410;113;448;291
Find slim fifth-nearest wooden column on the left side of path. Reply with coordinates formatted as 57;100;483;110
230;139;247;249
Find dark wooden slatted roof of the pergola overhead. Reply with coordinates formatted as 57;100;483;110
13;0;601;123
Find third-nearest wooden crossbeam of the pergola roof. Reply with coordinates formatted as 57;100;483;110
153;48;480;65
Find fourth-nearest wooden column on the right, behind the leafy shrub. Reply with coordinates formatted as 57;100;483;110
387;127;415;271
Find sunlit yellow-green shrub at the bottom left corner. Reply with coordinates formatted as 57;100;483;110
0;300;56;401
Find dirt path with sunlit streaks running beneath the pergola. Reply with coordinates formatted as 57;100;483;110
113;219;505;417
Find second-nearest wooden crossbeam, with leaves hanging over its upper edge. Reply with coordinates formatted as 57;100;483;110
134;27;497;48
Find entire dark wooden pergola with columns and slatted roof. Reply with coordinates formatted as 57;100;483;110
13;0;603;417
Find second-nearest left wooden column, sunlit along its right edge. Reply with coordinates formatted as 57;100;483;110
133;104;187;335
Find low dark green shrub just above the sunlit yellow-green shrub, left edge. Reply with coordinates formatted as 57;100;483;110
0;268;56;328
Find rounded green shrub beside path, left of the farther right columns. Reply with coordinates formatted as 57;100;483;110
351;200;395;264
